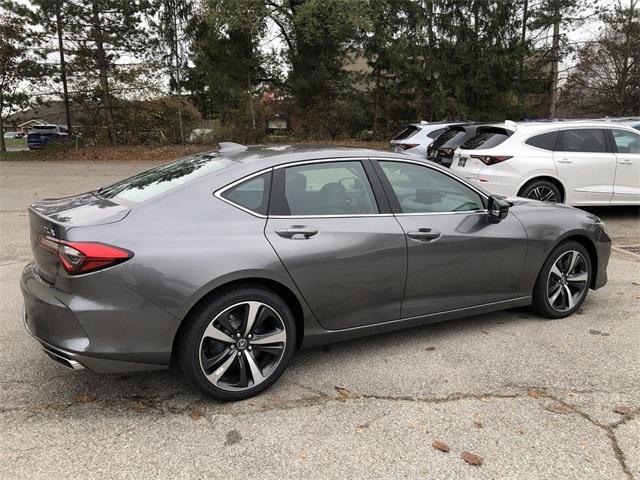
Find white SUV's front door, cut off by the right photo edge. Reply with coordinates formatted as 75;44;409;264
611;129;640;205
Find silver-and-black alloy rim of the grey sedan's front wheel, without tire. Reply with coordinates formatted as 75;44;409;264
547;250;589;312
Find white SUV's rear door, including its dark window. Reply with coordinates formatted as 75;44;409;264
553;128;616;205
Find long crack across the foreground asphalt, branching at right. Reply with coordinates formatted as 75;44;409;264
0;382;640;474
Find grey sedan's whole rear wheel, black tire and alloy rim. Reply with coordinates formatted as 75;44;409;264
178;287;296;401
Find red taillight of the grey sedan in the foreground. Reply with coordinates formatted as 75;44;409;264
39;235;133;275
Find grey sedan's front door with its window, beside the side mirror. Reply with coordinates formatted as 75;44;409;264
377;160;527;318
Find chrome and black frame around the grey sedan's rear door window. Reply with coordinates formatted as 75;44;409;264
268;157;393;219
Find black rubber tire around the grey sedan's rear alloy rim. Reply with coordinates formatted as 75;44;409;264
176;286;296;401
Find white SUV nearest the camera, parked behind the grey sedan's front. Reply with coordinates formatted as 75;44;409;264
451;121;640;205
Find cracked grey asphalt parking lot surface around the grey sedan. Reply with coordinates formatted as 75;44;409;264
0;162;640;480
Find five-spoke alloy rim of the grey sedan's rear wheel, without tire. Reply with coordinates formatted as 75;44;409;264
199;301;287;391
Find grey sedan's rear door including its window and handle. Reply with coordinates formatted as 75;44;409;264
265;159;407;330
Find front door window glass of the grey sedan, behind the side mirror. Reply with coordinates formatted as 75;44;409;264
379;161;484;213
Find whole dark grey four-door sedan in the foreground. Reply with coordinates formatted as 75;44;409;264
21;145;610;400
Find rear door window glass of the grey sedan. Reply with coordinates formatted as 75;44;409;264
284;161;378;215
